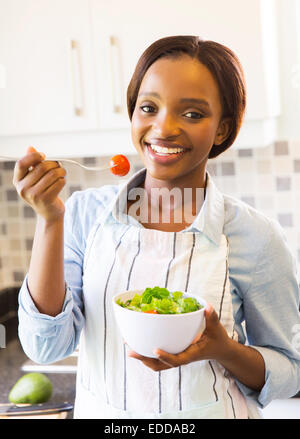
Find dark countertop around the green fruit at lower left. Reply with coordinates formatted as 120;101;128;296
0;339;76;419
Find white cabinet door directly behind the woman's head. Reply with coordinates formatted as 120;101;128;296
91;0;280;139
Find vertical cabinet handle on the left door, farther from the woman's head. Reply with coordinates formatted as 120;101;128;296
71;40;83;116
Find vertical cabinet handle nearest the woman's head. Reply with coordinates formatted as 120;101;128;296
109;36;122;113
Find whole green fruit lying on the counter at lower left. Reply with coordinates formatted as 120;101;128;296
8;372;52;404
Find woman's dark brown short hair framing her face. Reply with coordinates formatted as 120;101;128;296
127;35;246;158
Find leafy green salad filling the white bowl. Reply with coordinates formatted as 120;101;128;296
116;287;203;314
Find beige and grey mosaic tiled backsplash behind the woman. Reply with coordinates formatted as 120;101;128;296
0;142;300;290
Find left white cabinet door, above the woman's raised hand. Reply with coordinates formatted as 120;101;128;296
0;0;97;136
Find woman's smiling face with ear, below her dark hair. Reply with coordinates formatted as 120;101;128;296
131;55;229;186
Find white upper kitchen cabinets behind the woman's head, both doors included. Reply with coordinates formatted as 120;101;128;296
0;0;281;156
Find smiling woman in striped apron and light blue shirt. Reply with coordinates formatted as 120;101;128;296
14;36;300;418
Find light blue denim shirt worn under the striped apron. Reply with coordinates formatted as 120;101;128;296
19;169;300;407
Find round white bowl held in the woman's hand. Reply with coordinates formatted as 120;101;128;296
112;290;207;358
